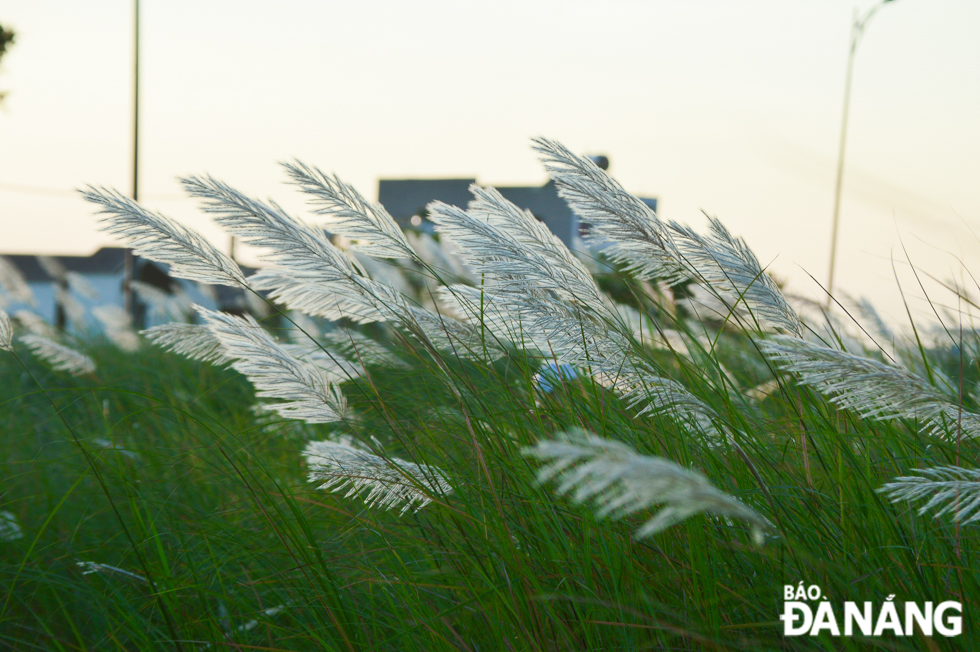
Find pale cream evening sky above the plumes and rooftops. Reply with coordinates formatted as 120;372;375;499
0;0;980;326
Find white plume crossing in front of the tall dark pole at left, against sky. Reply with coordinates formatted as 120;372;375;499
81;186;245;286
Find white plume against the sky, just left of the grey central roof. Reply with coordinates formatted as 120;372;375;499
282;161;418;259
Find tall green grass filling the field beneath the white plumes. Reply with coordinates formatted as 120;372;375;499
0;138;980;651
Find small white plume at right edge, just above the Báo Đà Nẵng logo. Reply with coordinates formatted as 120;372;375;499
877;466;980;525
